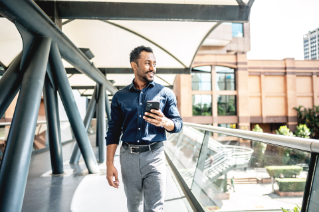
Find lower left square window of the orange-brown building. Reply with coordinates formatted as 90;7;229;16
193;95;212;116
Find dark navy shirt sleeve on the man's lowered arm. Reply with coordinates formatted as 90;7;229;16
106;94;123;145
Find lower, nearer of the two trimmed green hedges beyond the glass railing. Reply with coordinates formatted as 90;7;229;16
276;178;306;192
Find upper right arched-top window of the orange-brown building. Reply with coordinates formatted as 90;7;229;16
215;66;236;91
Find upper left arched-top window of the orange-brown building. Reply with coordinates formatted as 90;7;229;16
192;66;212;91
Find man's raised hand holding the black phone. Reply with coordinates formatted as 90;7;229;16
143;109;175;131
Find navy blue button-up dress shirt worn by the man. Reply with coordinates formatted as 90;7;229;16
106;80;183;145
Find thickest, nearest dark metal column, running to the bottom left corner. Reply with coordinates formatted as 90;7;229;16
0;37;51;212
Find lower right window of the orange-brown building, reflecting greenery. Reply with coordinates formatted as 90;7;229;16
217;95;237;116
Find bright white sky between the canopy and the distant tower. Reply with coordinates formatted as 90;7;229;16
247;0;319;60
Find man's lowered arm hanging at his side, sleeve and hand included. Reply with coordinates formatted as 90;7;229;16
106;95;123;188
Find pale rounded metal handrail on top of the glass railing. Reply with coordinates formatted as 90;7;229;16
183;122;319;153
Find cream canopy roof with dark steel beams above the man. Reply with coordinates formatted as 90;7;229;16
0;0;253;95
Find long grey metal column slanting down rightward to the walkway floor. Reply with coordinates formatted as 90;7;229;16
50;43;99;174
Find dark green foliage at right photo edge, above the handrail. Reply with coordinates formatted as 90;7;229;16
294;105;319;138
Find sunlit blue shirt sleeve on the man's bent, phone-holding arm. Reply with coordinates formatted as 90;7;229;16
163;89;183;133
